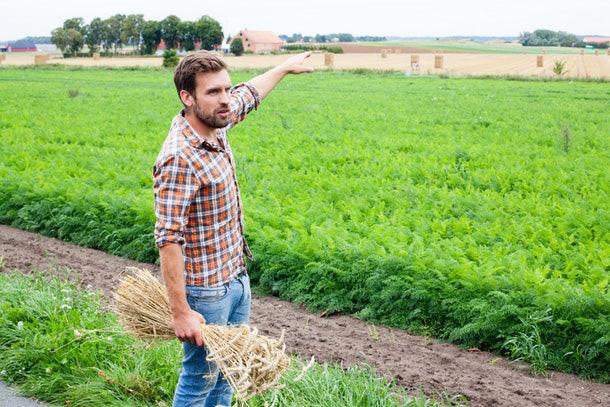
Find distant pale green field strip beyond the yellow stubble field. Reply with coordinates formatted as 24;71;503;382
358;40;592;54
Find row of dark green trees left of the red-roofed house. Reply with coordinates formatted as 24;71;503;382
51;14;224;55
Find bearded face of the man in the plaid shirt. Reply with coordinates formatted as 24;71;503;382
191;69;231;129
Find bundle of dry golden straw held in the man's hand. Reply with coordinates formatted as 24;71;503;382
115;267;290;402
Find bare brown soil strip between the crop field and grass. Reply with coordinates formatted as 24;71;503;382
0;225;610;407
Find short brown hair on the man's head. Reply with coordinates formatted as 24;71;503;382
174;51;228;101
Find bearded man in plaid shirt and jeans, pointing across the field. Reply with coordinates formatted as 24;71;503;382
153;52;312;407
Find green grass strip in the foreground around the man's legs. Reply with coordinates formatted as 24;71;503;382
0;268;448;407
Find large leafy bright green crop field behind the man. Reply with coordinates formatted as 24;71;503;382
0;67;610;382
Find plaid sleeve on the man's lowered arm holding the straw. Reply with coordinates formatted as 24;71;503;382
153;156;200;248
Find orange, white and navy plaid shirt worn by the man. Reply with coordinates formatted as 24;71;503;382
153;83;261;287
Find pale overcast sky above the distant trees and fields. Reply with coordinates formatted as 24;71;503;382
0;0;610;40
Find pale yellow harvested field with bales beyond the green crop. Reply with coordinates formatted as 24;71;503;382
0;50;610;79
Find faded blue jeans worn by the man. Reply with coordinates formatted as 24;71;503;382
173;274;252;407
